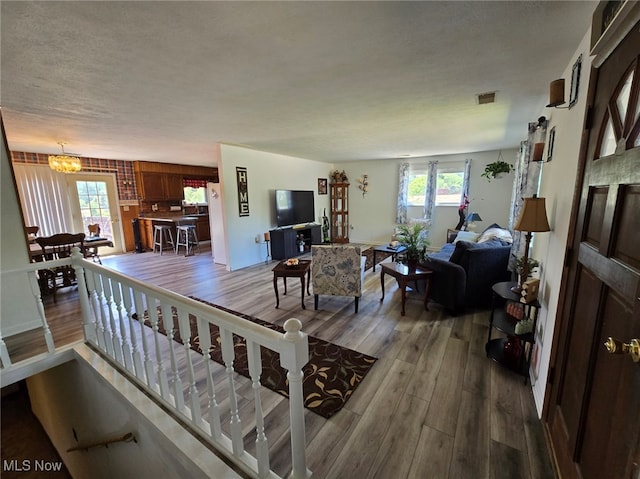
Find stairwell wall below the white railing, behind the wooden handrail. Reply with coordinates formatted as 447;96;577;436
27;346;238;479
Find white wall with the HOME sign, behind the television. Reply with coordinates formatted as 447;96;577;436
218;144;332;271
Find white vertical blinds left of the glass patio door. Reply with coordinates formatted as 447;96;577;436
13;163;73;236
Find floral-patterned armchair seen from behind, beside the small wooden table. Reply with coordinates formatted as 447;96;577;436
311;245;366;313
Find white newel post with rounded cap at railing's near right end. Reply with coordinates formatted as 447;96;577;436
280;318;311;479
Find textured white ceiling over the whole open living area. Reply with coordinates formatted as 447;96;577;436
0;0;596;164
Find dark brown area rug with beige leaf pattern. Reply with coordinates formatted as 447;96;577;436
135;296;377;418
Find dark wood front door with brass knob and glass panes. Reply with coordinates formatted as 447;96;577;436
544;19;640;479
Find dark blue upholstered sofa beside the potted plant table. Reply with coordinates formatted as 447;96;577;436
424;231;511;315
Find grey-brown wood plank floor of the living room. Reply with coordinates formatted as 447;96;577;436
9;246;555;479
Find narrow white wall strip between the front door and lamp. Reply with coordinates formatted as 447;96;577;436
531;30;591;414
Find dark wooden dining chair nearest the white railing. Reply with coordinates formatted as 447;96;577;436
36;233;85;303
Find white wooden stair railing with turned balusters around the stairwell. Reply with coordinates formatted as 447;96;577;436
0;250;311;479
